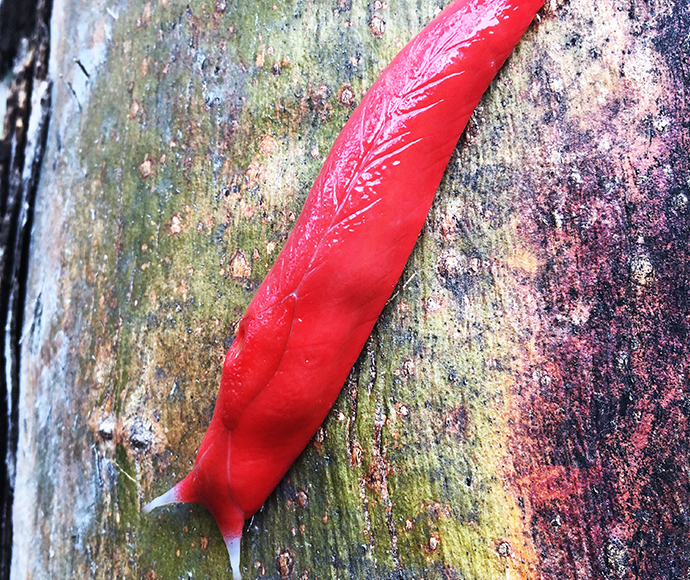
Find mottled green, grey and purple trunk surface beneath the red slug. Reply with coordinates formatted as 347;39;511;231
12;0;690;580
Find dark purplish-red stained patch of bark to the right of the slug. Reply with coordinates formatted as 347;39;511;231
502;3;690;580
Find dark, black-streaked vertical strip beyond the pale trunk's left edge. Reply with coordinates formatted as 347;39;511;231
0;0;52;580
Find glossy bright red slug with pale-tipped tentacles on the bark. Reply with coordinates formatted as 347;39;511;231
146;0;543;578
